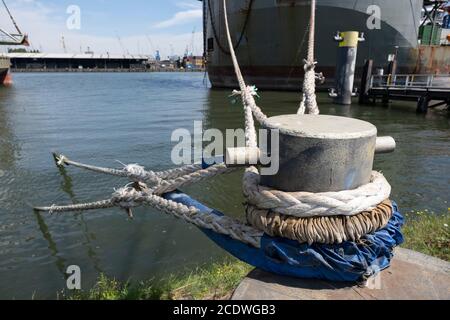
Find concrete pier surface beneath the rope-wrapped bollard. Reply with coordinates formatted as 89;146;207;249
232;248;450;300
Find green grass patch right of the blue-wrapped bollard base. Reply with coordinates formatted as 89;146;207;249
402;208;450;261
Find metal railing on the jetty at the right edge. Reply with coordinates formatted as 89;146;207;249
370;74;450;89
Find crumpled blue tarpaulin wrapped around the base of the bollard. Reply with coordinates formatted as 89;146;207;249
165;192;404;282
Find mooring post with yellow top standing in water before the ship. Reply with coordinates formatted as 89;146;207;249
330;31;364;105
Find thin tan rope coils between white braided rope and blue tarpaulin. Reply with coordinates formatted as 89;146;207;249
246;201;393;245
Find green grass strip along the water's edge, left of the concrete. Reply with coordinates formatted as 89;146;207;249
66;259;252;300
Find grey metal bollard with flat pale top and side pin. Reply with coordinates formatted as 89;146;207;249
261;115;395;193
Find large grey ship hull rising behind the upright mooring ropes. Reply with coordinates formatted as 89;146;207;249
204;0;422;90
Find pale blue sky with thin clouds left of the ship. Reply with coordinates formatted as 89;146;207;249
0;0;203;56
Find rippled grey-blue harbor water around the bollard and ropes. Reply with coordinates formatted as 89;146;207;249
0;73;450;299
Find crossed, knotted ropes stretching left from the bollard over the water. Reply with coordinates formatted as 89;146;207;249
40;155;262;247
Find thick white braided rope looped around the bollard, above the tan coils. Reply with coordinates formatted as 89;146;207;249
243;167;391;218
